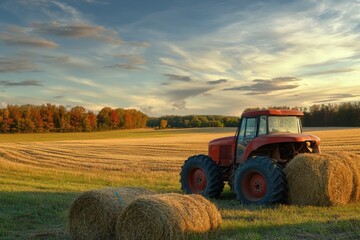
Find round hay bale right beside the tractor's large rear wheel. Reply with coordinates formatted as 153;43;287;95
285;154;353;206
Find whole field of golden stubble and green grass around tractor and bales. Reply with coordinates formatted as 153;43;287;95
0;128;360;239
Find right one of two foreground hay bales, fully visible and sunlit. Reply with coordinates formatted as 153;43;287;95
116;193;222;240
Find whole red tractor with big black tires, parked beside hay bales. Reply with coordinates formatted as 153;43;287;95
180;110;320;204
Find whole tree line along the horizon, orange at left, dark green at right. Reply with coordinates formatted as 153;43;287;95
0;102;360;133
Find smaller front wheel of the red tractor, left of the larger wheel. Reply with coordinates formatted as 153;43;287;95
180;154;224;198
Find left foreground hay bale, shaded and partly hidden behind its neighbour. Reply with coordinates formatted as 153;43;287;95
69;188;152;240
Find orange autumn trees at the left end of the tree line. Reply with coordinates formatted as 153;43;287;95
0;104;148;133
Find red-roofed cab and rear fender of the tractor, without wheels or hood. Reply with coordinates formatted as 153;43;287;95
234;110;320;164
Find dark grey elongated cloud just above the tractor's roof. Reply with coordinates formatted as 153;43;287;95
224;77;300;95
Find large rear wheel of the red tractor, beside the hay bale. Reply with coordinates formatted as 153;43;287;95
234;156;286;205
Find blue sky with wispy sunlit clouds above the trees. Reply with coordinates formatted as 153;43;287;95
0;0;360;116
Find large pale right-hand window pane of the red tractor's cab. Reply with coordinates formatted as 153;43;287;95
269;116;301;133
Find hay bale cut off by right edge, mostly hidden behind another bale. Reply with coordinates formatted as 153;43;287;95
333;152;360;202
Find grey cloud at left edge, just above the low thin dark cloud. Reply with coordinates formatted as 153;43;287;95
0;57;38;73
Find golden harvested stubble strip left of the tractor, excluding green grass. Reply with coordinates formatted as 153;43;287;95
0;134;220;172
